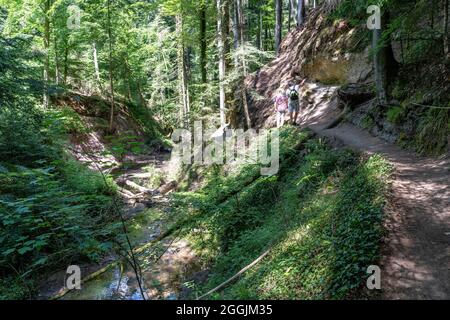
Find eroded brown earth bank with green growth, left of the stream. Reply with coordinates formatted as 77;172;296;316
54;92;163;170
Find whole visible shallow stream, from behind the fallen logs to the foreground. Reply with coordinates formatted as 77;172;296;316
42;155;201;300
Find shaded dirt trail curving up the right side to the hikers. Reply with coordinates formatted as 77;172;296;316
300;87;450;299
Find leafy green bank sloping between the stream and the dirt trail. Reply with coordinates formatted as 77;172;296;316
172;127;390;299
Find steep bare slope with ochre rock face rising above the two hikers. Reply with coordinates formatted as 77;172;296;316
241;8;372;128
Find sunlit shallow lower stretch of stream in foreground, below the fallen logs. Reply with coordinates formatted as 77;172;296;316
61;208;200;300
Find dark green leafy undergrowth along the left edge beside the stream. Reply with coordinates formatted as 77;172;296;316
0;105;120;299
